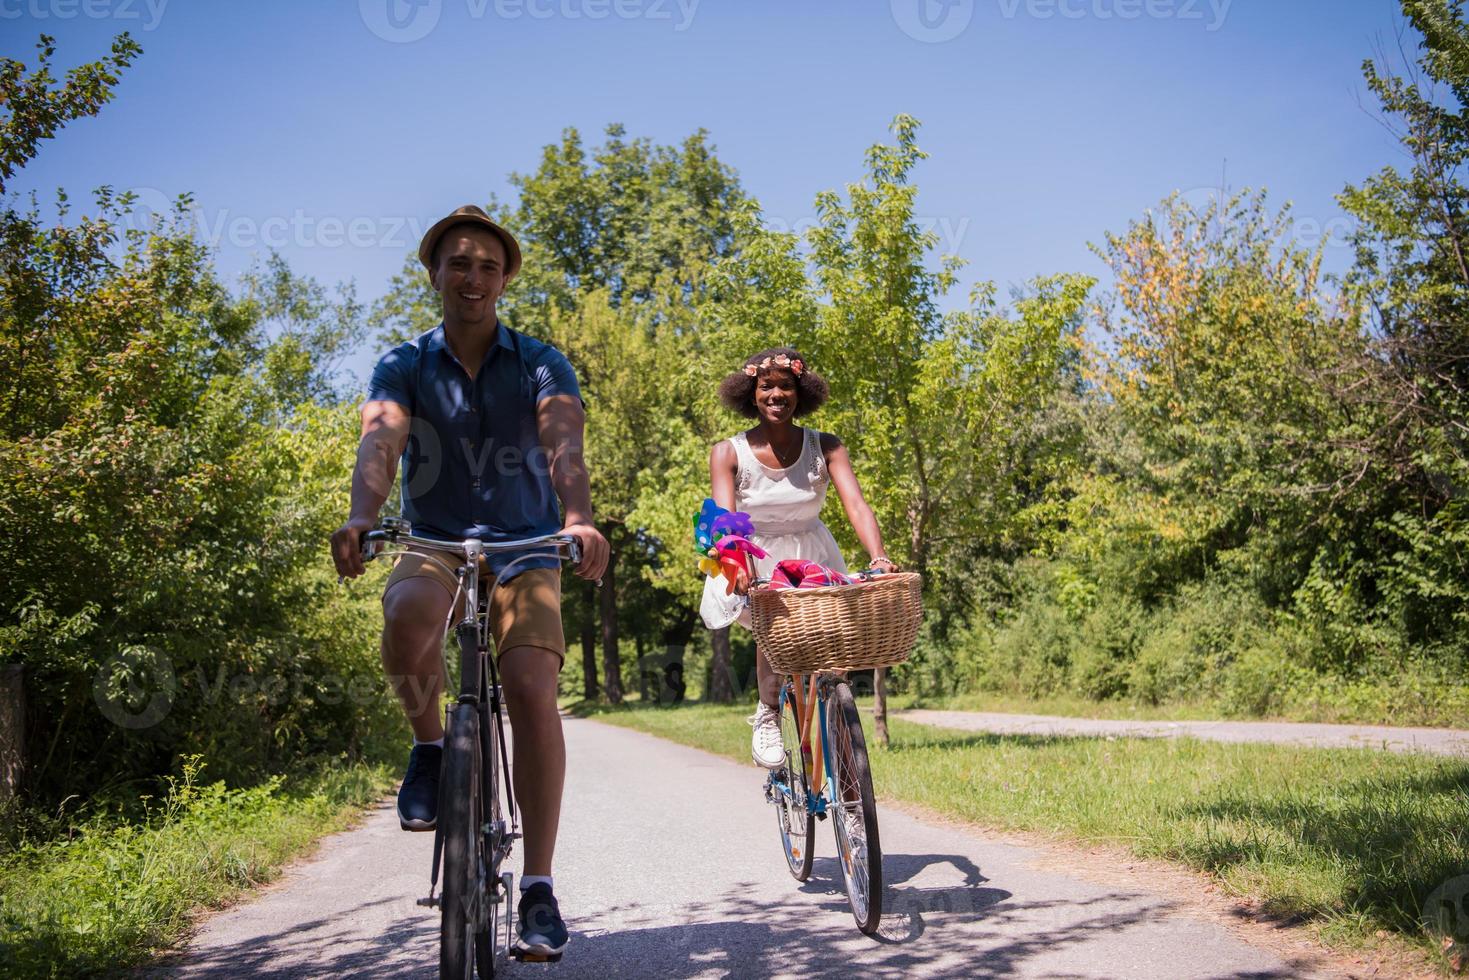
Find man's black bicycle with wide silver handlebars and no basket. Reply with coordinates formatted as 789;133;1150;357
361;519;580;979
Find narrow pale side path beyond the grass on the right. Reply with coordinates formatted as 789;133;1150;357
895;708;1469;755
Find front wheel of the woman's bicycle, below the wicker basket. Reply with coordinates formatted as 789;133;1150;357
827;680;883;936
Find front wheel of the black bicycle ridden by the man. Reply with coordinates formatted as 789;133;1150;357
439;704;494;980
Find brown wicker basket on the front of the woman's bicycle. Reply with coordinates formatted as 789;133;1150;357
749;572;923;674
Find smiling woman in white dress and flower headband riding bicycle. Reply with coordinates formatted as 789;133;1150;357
699;347;898;768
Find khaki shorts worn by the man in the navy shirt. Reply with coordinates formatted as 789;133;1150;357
382;554;566;664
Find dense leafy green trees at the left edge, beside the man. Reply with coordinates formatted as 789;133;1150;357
0;38;389;799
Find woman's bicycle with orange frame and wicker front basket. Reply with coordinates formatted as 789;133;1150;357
749;572;923;934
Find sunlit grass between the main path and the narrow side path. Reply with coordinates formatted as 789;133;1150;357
582;705;1469;963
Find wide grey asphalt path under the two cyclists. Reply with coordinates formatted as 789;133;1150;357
157;718;1333;980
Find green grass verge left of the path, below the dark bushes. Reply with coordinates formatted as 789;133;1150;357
0;761;392;977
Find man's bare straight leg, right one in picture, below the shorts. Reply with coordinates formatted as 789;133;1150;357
499;646;566;876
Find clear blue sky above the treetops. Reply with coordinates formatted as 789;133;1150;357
0;0;1416;379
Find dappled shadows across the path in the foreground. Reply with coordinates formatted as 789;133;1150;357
150;854;1291;980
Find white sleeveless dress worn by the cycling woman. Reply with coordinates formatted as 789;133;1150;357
699;429;846;629
